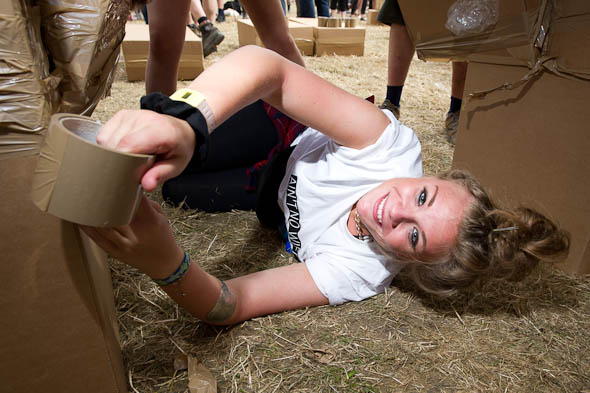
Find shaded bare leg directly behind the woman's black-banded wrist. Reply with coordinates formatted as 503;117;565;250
145;0;190;95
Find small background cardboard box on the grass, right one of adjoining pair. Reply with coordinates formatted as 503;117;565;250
291;18;366;56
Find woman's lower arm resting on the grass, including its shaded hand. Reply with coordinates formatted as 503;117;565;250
82;197;328;325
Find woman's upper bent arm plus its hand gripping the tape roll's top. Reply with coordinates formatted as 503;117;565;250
98;46;389;191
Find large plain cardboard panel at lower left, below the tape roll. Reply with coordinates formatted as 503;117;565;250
0;155;127;393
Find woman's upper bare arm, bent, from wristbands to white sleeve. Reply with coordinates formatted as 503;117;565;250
189;46;389;148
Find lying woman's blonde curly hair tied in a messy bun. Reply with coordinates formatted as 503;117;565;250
407;170;570;296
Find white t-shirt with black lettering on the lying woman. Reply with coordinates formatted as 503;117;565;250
279;111;422;304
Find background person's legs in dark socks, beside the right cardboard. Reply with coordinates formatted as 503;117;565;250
377;0;467;145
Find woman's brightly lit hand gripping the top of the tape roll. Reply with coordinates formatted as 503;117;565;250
96;109;195;191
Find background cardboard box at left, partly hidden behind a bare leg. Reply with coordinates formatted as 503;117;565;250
122;23;205;81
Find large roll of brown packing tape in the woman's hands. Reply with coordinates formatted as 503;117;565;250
31;113;154;227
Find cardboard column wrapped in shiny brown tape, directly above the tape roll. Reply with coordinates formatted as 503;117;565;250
40;0;131;116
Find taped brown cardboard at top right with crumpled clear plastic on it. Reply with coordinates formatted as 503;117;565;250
399;0;547;62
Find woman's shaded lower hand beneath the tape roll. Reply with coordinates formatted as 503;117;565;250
80;195;184;279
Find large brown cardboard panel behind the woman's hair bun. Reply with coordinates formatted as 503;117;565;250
453;62;590;274
